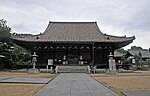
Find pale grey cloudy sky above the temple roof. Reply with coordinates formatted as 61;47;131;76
0;0;150;49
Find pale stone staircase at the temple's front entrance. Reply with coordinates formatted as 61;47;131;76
55;66;90;73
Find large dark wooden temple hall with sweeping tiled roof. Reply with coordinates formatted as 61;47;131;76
12;22;135;67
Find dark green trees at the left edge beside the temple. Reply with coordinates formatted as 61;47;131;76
0;19;31;69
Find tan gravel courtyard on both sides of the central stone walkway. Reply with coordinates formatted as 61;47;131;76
0;71;150;96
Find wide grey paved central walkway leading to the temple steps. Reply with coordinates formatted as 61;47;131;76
36;73;118;96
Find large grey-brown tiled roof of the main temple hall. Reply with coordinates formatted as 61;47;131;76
13;22;135;42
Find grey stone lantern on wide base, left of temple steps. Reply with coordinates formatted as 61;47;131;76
28;52;40;74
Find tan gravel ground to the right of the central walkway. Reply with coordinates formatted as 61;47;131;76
91;71;150;95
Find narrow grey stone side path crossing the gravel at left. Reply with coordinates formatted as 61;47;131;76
0;77;52;84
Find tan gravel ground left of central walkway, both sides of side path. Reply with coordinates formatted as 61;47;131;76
0;72;56;96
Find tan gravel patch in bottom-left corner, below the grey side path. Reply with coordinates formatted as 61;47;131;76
0;83;44;96
